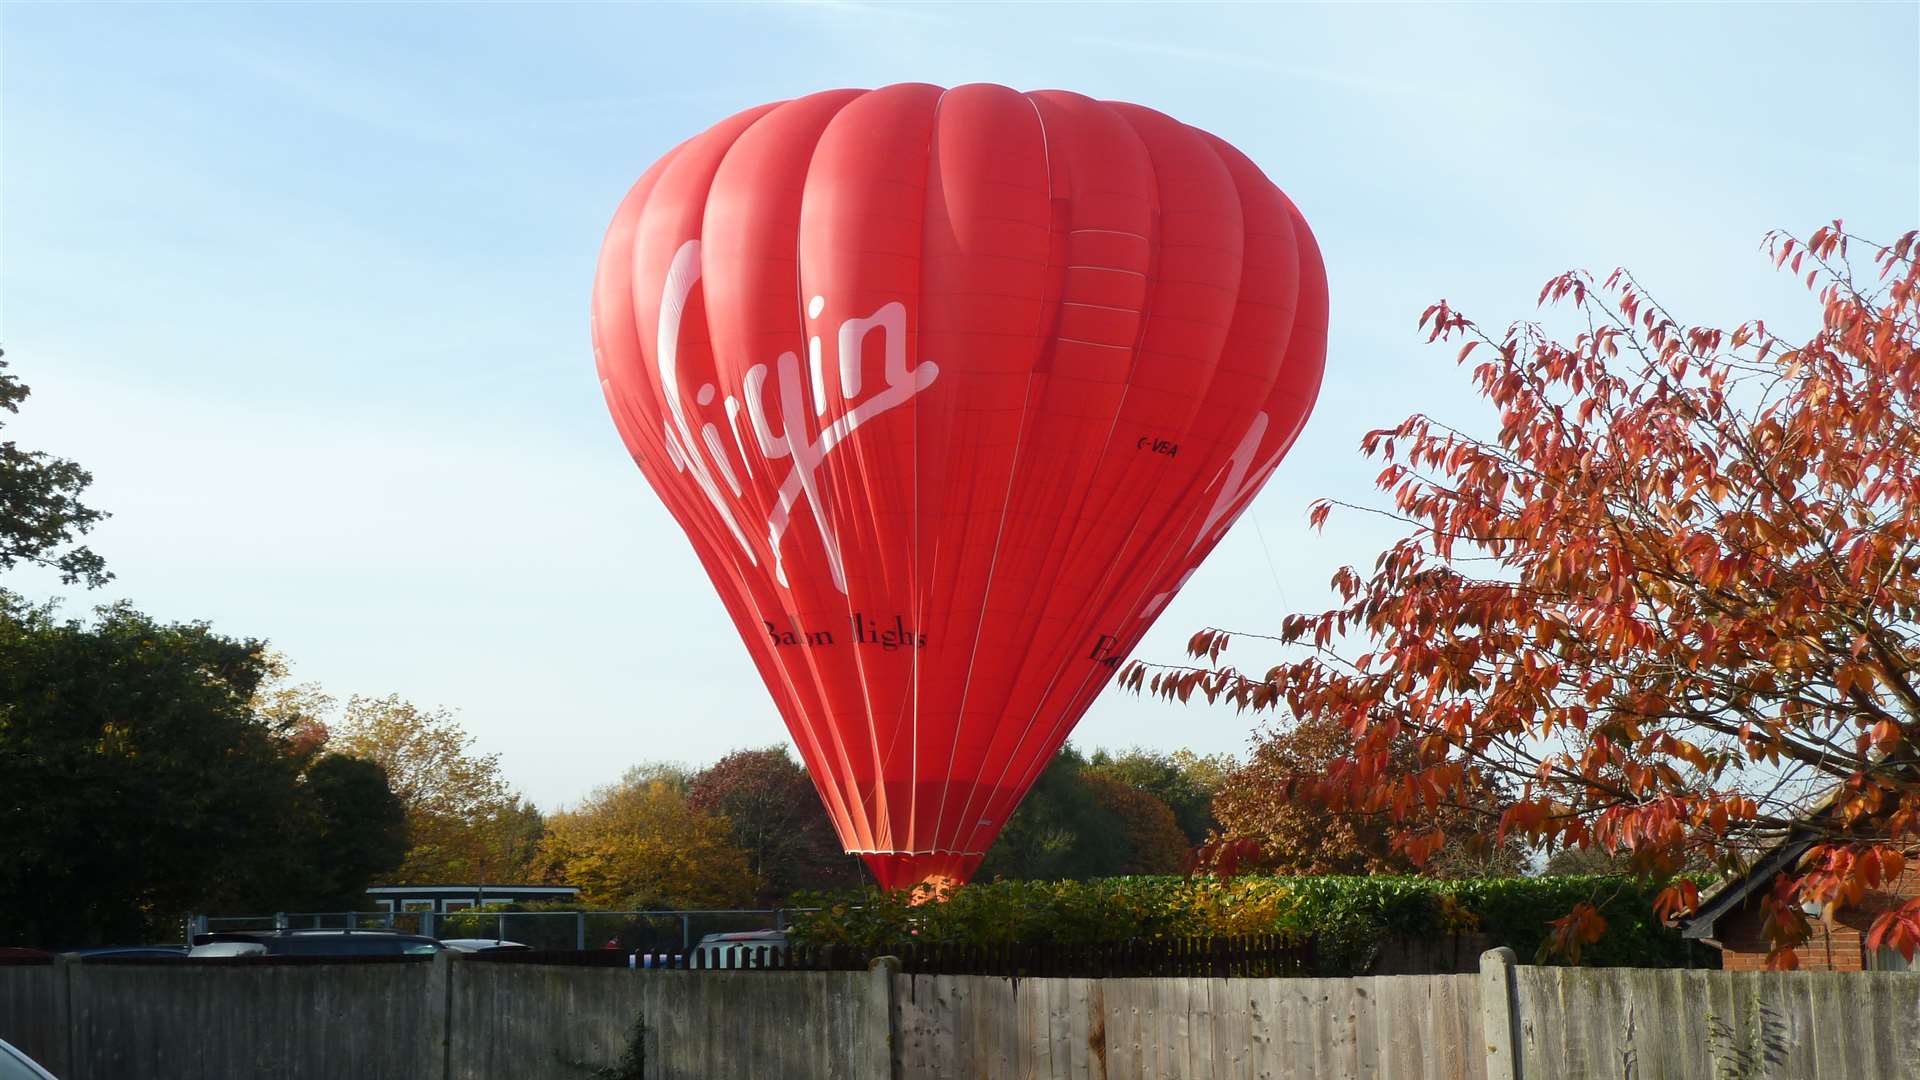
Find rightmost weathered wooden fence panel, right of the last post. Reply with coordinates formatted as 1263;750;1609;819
1513;967;1920;1080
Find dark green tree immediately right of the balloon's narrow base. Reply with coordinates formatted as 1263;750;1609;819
975;746;1131;880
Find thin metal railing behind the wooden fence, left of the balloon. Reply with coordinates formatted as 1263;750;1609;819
188;907;804;951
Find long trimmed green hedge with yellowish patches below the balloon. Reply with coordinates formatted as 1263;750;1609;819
793;876;1716;974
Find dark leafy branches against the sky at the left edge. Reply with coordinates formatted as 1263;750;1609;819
0;351;113;588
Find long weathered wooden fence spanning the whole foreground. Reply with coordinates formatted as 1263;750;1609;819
0;949;1920;1080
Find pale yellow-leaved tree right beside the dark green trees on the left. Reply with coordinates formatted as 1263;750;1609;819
328;688;540;884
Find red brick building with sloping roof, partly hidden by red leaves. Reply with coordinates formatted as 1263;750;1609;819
1680;826;1920;970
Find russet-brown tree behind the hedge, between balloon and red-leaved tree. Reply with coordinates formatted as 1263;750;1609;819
1200;719;1524;876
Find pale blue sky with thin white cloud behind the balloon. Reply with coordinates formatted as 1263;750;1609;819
0;4;1920;805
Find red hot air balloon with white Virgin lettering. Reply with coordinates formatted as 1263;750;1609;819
593;85;1327;888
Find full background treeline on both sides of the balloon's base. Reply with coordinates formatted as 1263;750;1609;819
0;349;1605;945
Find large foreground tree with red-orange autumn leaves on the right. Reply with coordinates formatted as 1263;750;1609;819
1123;221;1920;967
